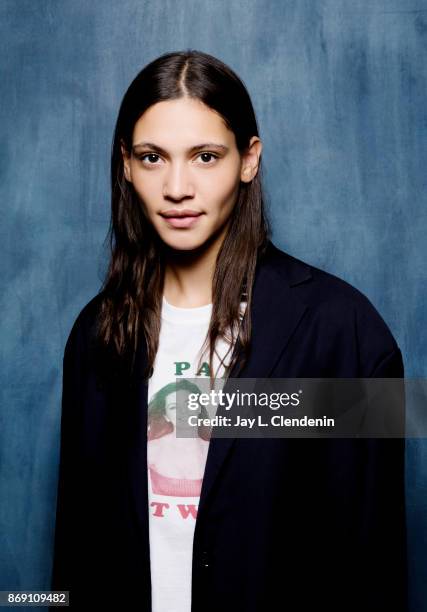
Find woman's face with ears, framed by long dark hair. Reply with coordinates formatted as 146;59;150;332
122;97;262;250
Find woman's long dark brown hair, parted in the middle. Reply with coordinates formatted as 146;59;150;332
97;50;270;384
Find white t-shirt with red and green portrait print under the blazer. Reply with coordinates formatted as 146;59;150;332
147;296;246;612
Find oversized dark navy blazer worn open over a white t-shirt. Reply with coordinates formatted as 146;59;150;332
52;242;407;612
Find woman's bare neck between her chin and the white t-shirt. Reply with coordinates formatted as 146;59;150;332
163;225;224;308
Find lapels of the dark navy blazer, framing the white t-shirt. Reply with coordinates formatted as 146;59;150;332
128;241;311;529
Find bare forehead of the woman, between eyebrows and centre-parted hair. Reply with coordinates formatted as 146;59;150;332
133;98;235;150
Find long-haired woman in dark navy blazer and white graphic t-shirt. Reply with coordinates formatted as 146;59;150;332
52;51;406;612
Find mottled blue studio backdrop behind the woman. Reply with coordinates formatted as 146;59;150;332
0;0;427;612
